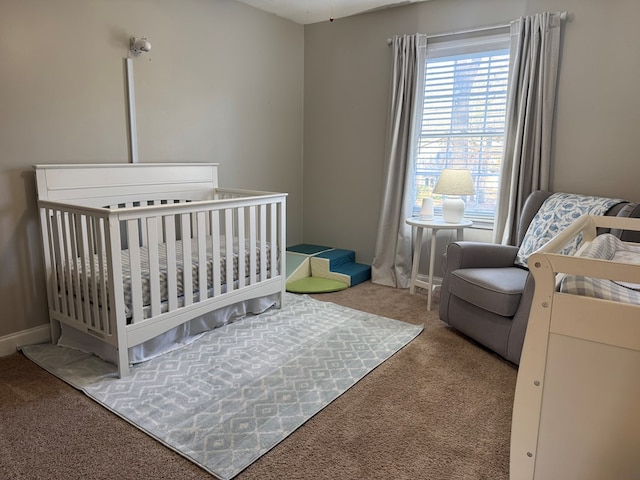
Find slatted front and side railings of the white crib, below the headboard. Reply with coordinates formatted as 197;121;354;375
39;189;286;346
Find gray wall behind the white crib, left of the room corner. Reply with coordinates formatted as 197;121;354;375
0;0;304;340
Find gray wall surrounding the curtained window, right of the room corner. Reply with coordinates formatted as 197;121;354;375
303;0;640;262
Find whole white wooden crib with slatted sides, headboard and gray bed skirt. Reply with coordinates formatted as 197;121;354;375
34;163;286;376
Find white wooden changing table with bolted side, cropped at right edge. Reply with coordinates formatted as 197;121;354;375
510;216;640;480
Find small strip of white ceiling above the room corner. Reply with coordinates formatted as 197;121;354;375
238;0;426;25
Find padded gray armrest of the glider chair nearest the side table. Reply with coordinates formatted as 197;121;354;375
443;242;519;272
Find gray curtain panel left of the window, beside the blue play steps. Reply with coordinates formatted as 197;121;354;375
371;34;427;288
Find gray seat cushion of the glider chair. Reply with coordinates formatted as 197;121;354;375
449;267;529;317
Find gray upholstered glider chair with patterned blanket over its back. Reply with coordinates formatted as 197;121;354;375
440;190;640;364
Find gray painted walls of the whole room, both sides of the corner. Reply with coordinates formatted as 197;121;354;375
5;0;640;340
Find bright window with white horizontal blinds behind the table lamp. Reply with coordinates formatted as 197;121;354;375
414;34;509;223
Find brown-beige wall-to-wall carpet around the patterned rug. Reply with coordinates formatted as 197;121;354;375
0;282;516;480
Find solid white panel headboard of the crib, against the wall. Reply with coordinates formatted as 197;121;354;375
33;163;218;206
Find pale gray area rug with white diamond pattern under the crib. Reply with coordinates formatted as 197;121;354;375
22;293;423;480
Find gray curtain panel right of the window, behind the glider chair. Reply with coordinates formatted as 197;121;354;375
493;12;562;245
